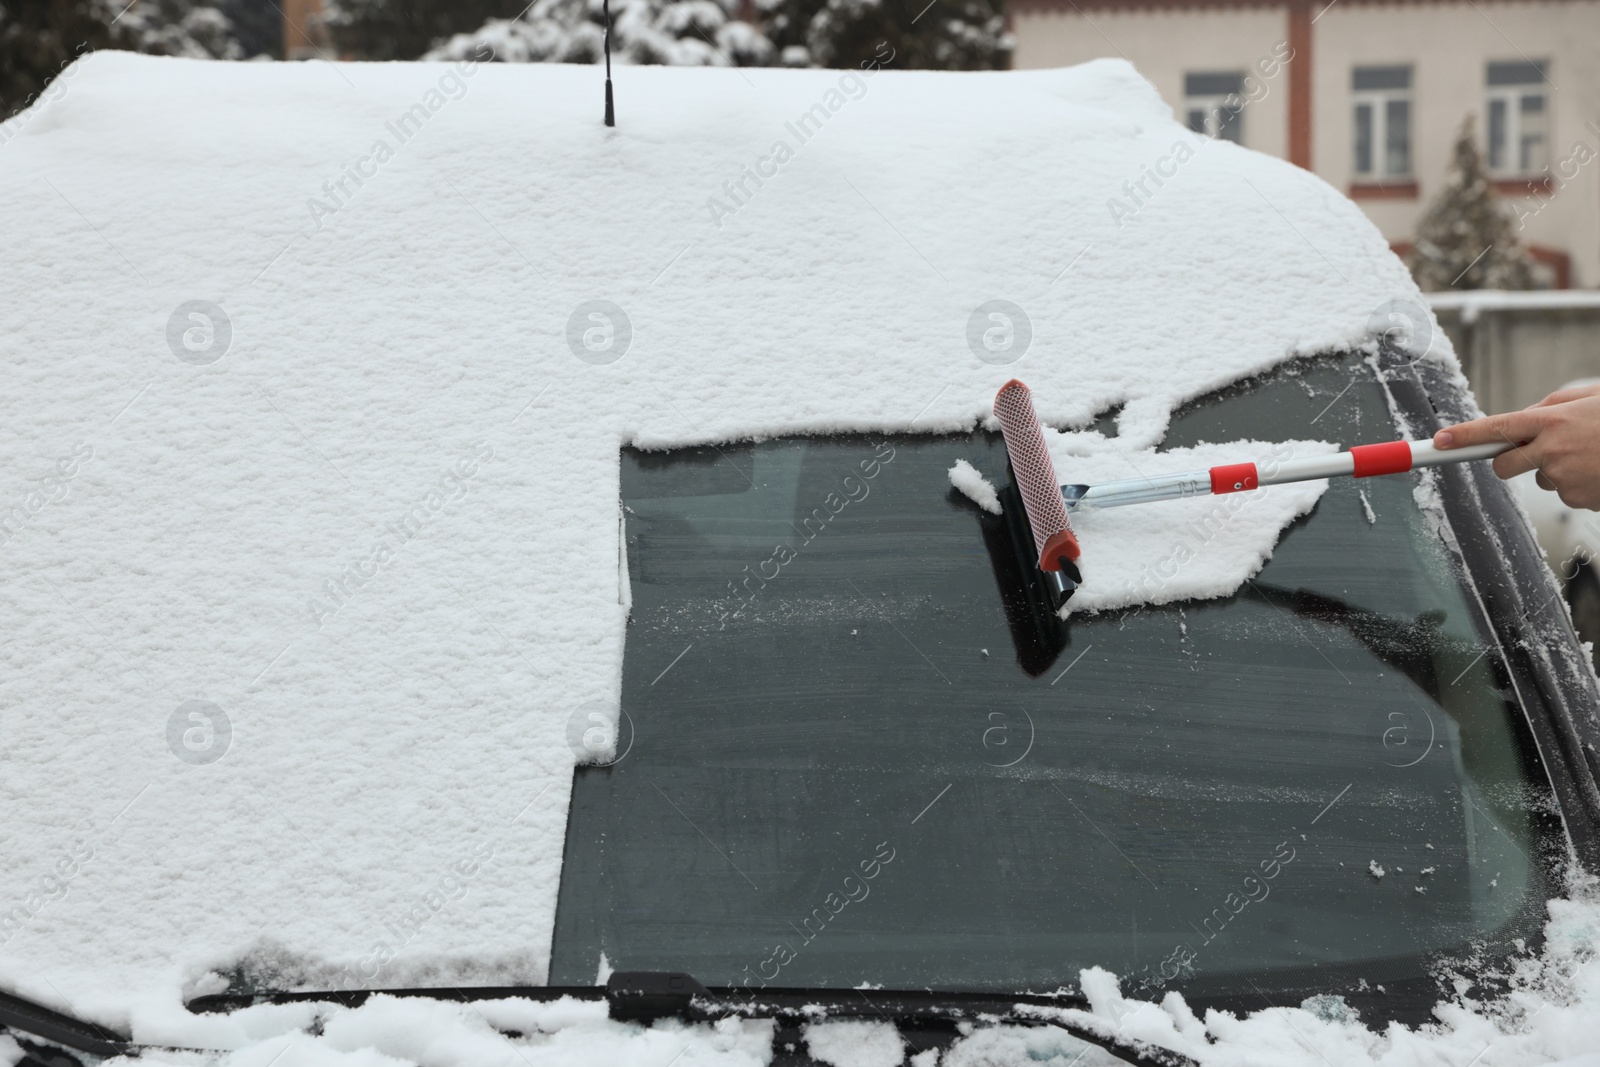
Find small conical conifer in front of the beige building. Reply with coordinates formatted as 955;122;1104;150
1406;117;1539;290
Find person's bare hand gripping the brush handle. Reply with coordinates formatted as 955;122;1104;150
1434;384;1600;510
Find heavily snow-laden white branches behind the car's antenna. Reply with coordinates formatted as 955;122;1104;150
426;0;773;67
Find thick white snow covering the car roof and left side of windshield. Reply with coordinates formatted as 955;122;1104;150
0;43;1510;1059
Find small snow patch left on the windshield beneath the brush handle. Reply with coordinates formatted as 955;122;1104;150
1030;429;1339;613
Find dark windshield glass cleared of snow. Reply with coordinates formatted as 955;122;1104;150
550;357;1552;1006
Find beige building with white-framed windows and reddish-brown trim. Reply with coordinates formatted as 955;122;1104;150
1010;0;1600;288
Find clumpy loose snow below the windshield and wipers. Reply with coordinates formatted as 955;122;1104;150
78;880;1600;1067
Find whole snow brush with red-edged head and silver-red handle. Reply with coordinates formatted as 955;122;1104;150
995;378;1515;605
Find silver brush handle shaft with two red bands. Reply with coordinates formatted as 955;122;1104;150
1061;442;1515;510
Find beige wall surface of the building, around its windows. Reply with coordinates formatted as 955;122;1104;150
1013;0;1600;288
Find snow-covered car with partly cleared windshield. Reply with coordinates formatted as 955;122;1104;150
0;54;1600;1067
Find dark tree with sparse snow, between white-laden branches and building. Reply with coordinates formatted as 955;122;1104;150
757;0;1016;70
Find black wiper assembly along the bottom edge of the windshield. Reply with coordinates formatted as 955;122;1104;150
187;971;1197;1067
